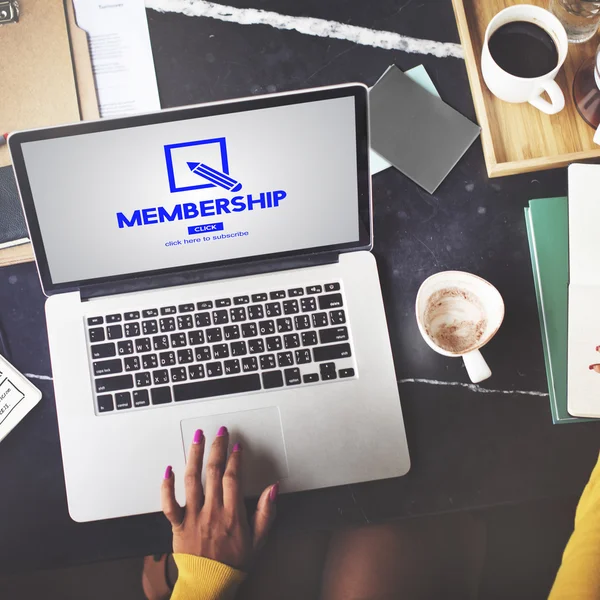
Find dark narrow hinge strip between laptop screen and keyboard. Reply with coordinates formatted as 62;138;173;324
80;252;339;301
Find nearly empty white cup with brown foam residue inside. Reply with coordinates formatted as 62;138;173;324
415;271;504;383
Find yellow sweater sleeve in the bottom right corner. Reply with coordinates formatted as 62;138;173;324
549;460;600;600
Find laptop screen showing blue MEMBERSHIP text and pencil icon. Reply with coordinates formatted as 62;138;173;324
11;88;370;292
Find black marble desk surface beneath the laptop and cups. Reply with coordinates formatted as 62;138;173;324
0;0;600;570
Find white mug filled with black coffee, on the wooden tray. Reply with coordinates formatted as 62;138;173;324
481;4;569;115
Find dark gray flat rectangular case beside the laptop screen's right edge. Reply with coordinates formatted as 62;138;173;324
369;65;480;194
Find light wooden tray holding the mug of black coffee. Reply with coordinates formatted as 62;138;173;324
452;0;600;177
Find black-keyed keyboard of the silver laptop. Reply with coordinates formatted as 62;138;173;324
86;282;356;413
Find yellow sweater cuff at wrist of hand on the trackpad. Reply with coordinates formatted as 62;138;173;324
171;554;246;600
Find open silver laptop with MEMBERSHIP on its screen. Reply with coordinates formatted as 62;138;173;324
8;84;409;522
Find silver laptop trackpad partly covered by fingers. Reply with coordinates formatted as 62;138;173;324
181;406;288;496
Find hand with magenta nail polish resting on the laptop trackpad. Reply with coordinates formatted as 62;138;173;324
161;427;279;570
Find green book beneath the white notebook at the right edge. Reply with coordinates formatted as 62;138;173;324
525;197;590;424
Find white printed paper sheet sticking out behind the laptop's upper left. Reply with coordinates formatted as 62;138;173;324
75;0;160;118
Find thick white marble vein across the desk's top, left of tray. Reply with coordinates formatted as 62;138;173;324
146;0;464;58
